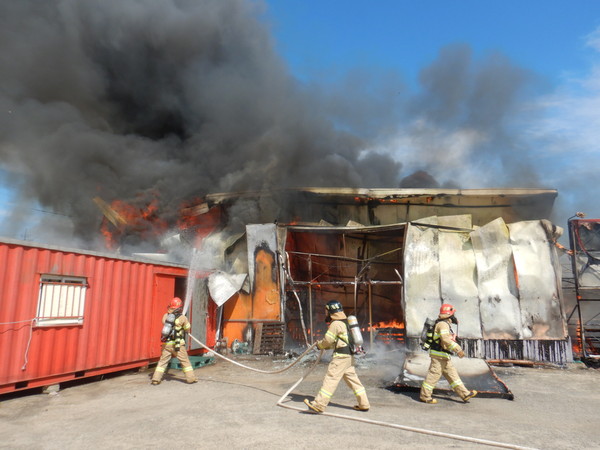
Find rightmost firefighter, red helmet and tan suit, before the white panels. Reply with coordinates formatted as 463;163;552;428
419;304;477;404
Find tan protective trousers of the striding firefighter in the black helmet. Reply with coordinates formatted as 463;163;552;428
313;355;369;411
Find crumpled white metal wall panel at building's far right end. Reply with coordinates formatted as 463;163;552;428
508;220;566;339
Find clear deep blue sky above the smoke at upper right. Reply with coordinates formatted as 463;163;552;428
267;0;600;87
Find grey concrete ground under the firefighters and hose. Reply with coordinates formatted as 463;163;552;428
0;355;600;449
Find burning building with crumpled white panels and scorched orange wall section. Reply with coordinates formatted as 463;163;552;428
126;189;571;363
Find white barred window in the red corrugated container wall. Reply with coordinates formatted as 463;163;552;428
36;275;88;326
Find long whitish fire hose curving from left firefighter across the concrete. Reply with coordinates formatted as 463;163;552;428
189;334;535;450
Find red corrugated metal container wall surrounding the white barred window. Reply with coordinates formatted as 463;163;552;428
0;242;193;393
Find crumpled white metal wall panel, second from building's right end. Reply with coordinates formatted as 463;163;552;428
471;218;523;339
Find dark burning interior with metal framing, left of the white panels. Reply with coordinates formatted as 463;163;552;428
282;225;406;347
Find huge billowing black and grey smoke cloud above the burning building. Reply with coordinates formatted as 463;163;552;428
0;0;544;248
